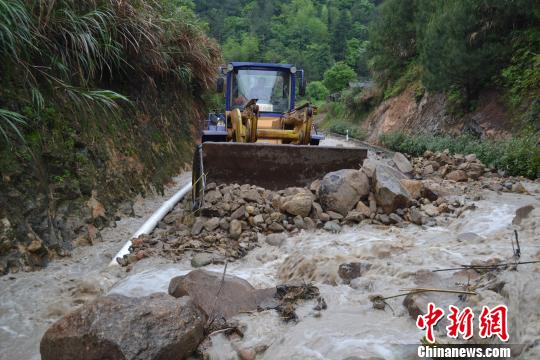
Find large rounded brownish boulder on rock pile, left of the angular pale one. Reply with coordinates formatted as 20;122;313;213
318;169;369;216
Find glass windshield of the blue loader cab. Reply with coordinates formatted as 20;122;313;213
231;69;291;113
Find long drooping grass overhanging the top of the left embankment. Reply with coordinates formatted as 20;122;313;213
0;0;220;143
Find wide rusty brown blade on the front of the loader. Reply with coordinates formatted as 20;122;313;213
197;142;367;190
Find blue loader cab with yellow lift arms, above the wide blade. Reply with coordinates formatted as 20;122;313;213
202;62;314;145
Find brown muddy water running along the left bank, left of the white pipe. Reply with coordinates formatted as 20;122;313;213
0;174;190;360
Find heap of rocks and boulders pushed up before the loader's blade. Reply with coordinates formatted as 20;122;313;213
119;156;477;267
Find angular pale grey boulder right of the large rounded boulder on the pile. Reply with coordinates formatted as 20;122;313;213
373;165;411;214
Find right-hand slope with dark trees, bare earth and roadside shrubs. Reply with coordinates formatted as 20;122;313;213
364;0;540;178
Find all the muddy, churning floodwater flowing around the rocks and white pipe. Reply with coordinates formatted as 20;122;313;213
0;137;540;360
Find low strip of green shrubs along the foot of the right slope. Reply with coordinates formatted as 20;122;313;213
380;130;540;179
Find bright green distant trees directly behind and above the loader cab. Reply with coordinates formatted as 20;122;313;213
193;0;375;81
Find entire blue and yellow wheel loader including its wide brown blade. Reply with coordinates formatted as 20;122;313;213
192;62;367;208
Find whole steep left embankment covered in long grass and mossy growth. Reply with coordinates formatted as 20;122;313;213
0;0;221;266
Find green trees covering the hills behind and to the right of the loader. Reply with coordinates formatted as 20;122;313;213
196;0;540;133
